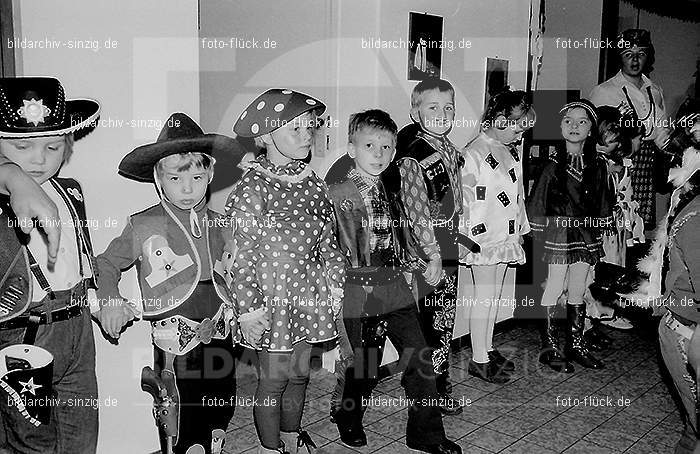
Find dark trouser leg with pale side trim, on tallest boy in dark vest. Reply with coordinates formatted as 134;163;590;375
416;265;457;394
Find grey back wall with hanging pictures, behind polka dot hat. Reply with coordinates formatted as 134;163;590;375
200;0;529;208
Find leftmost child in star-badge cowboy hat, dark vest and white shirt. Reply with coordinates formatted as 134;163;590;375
0;77;100;454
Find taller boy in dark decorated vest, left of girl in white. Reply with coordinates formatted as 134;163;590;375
389;79;462;414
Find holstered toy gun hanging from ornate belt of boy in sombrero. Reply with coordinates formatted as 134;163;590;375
141;366;180;454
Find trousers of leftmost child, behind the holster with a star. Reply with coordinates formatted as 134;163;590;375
0;298;99;454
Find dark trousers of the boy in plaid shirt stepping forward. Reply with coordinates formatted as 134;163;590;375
336;278;445;444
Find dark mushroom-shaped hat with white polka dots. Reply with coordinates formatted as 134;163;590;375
233;88;326;137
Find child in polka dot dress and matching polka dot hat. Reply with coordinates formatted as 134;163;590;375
226;89;345;453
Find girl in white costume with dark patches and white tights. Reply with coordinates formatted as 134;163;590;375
460;89;534;383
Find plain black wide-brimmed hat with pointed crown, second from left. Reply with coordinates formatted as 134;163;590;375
119;112;243;183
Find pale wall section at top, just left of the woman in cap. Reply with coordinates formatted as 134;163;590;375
537;0;603;97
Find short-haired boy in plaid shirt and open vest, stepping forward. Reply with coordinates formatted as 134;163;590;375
327;110;461;453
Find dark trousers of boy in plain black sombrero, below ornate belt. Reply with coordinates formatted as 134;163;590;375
154;339;236;454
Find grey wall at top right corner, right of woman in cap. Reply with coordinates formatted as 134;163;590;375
618;2;700;119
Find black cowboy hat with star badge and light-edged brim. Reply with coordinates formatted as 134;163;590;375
0;77;100;138
